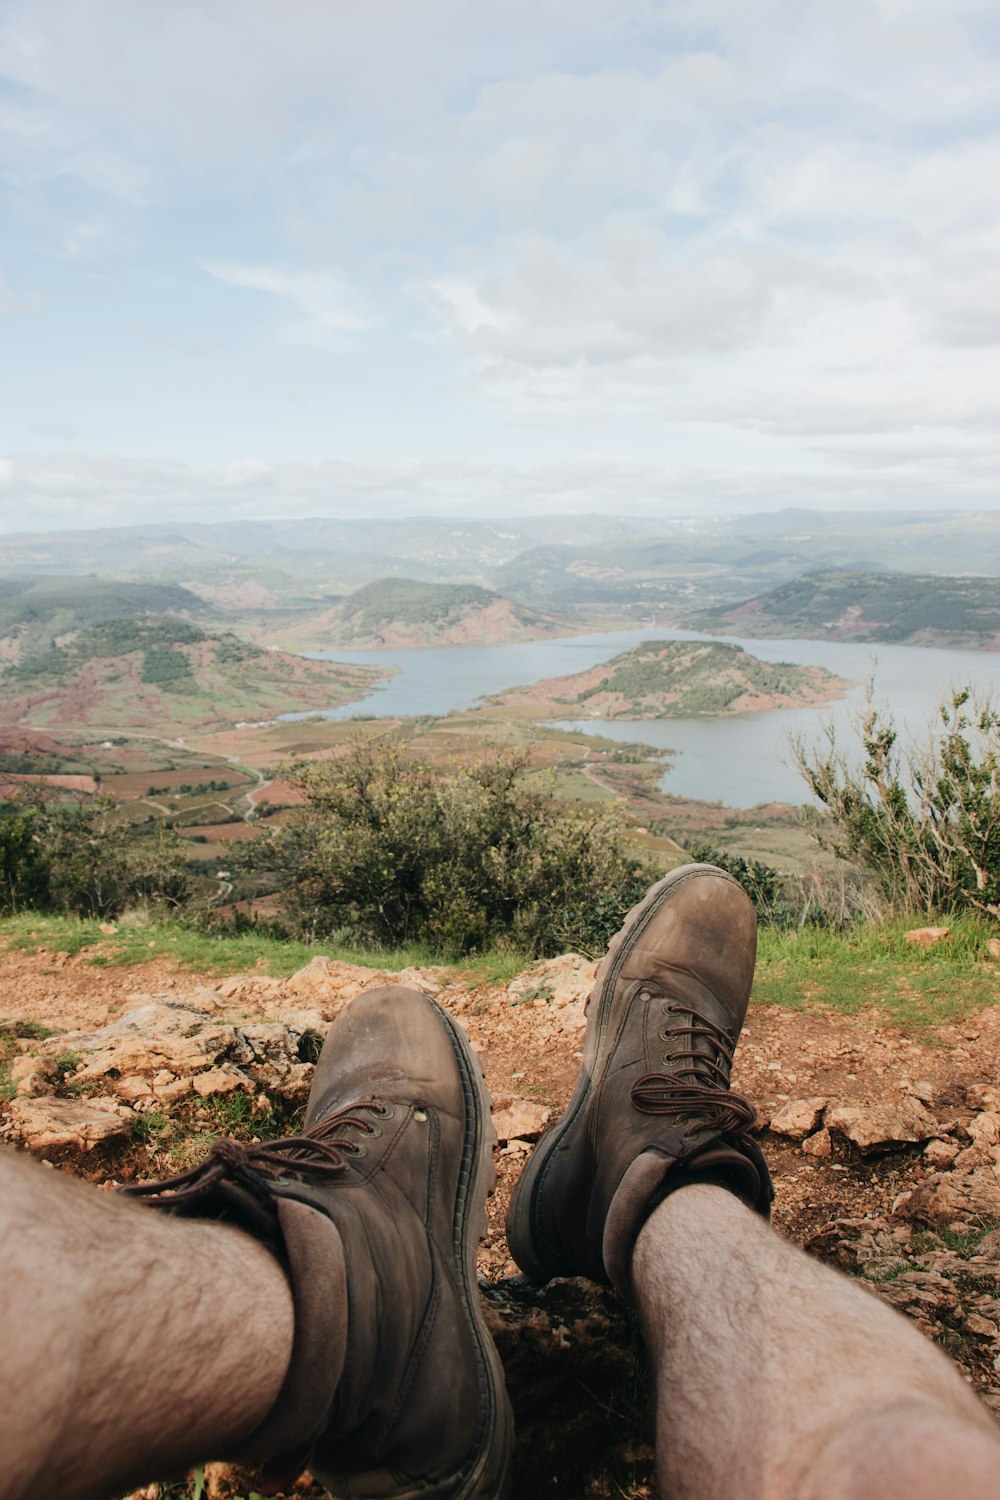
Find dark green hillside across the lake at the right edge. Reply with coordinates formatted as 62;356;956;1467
687;569;1000;648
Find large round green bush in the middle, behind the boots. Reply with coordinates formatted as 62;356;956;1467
244;740;658;957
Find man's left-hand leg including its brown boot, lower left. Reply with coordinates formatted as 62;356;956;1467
0;987;511;1500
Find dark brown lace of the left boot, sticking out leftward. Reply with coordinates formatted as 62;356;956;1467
118;1100;393;1205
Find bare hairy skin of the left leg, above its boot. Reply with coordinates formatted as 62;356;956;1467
0;1149;294;1500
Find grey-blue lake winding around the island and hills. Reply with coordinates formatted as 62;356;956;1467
293;626;1000;807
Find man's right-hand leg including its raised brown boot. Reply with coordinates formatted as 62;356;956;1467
507;866;1000;1500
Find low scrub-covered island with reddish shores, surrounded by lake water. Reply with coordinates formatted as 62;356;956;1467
484;641;853;719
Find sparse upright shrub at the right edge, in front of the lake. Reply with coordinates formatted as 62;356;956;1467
793;689;1000;917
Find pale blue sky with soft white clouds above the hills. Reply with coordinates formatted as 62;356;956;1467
0;0;1000;533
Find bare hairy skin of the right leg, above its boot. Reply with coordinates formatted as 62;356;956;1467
631;1184;1000;1500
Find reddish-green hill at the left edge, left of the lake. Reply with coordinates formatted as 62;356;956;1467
0;617;379;735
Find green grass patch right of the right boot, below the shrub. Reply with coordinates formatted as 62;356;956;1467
754;915;1000;1031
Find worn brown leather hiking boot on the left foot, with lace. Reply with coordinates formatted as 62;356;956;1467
124;987;511;1500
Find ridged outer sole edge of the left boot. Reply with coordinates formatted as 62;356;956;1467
431;1001;514;1500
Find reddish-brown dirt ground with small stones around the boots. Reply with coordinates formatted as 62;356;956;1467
0;950;1000;1500
